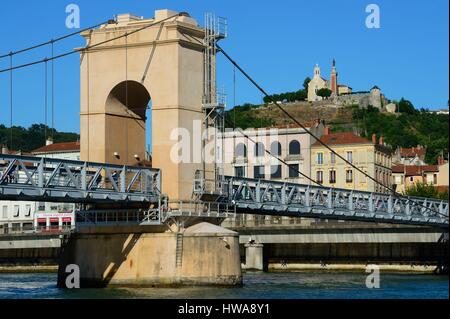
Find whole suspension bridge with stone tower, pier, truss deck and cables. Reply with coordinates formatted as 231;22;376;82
0;10;449;285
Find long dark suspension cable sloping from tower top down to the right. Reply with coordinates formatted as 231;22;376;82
216;44;448;218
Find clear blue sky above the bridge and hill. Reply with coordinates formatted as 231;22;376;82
0;0;449;139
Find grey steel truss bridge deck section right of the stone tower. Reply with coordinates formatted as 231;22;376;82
225;176;449;228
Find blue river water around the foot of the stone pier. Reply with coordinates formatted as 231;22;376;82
0;271;449;299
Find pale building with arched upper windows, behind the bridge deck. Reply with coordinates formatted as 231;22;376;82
222;120;328;227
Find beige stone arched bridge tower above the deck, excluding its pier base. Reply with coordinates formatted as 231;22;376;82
80;10;204;199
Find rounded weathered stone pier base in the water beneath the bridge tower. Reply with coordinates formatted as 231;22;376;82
58;223;242;288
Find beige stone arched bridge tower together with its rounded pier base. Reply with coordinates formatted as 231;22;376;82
64;10;242;287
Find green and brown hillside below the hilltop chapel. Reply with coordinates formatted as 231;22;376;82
227;99;449;164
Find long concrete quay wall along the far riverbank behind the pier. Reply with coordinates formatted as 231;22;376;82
0;225;449;272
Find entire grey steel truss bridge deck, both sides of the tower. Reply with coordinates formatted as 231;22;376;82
0;155;449;228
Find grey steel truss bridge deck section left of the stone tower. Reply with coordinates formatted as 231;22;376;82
0;154;161;203
